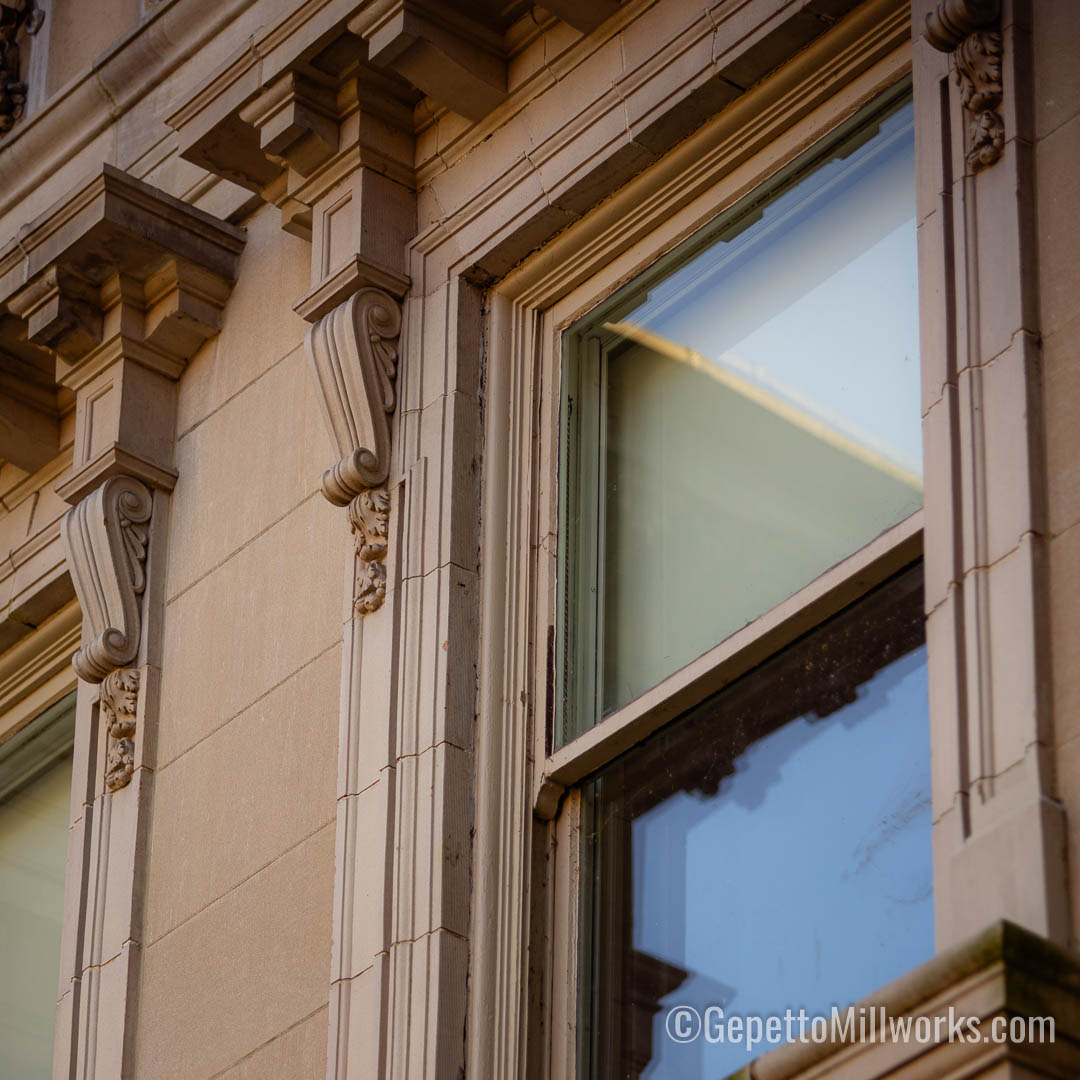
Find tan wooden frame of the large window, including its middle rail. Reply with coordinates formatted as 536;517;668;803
470;6;923;1080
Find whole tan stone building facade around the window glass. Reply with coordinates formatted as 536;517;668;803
0;0;1080;1080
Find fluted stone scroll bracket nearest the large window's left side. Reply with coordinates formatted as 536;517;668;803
305;288;402;507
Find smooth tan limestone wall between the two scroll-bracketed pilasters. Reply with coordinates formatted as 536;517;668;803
136;208;349;1080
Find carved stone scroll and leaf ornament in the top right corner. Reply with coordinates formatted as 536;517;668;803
923;0;1005;172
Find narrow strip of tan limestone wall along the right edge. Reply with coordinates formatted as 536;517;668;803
1032;0;1080;944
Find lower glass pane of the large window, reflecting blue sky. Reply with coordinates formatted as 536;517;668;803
581;568;933;1080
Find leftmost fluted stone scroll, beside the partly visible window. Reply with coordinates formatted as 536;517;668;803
60;476;153;683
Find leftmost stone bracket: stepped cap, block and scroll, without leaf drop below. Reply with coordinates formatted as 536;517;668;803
0;165;244;683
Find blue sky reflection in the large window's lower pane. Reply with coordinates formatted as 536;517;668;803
632;646;933;1080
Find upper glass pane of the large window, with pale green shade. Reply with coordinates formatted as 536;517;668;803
555;89;922;743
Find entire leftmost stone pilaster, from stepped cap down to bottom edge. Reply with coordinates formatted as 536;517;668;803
0;165;243;1080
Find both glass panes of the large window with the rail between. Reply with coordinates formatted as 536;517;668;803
549;85;933;1078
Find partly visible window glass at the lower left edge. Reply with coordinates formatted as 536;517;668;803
0;693;75;1080
